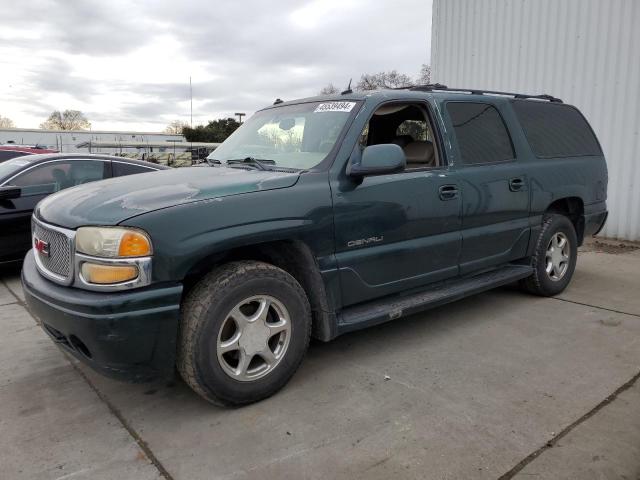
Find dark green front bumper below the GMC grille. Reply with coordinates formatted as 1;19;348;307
22;251;182;382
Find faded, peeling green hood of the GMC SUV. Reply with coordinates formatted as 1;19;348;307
35;167;299;228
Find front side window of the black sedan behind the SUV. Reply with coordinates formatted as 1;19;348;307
9;160;105;195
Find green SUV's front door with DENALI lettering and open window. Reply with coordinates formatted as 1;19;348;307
331;101;462;306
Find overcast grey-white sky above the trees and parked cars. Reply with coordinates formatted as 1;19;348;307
0;0;431;131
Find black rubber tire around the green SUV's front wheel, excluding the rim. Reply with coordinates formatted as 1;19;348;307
177;261;311;406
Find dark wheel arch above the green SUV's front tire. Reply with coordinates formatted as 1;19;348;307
183;240;336;341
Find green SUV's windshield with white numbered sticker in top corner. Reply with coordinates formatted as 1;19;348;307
207;102;356;170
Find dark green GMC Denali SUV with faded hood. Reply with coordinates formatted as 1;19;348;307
22;85;607;405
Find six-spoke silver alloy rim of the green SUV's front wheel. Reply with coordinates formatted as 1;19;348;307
216;295;291;382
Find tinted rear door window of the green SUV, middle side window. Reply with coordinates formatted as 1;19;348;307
447;102;515;165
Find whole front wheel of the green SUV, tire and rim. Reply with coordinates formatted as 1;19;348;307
178;261;311;406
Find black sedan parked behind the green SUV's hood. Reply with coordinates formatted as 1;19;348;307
0;153;167;263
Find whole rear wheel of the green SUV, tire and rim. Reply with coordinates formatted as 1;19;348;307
522;214;578;297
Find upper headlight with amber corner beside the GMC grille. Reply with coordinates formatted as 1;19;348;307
76;227;152;258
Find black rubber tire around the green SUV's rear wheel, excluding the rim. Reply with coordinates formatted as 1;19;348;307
521;214;578;297
